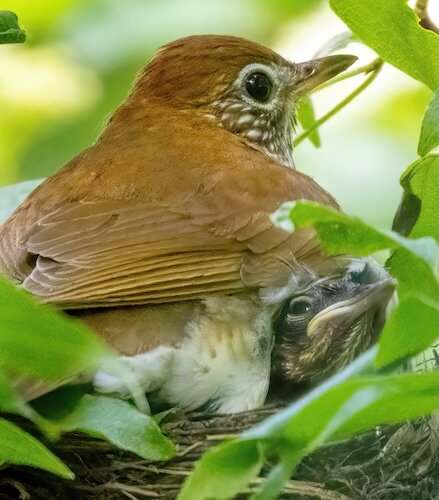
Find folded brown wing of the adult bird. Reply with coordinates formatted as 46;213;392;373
2;169;336;309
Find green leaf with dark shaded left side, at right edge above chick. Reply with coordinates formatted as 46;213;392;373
393;151;439;241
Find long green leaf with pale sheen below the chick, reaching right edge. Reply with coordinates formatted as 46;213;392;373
256;373;439;474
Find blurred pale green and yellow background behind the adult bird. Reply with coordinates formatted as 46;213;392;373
0;0;434;227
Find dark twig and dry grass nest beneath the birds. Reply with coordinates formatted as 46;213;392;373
0;406;439;500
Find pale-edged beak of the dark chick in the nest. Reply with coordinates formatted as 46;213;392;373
307;277;396;341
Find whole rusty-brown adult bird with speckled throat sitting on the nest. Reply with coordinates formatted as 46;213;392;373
0;36;392;411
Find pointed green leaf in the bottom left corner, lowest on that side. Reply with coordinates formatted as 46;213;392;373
0;419;74;479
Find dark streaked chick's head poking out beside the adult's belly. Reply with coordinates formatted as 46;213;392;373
272;259;395;389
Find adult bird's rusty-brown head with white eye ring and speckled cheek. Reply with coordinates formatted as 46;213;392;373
134;35;356;166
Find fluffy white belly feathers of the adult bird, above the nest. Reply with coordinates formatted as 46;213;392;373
94;297;273;413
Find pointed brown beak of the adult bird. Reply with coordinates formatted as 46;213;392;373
294;55;358;95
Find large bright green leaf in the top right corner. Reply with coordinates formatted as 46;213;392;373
330;0;439;91
